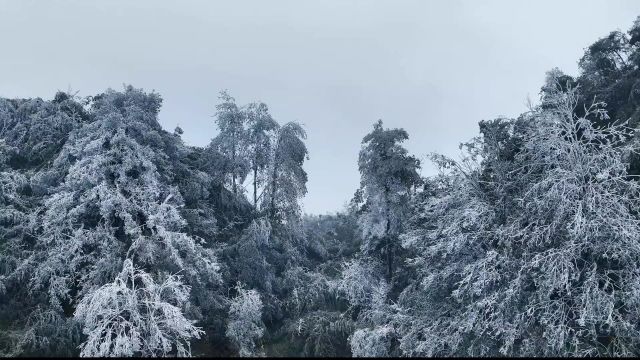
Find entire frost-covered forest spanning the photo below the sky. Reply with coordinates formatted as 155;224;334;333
0;18;640;356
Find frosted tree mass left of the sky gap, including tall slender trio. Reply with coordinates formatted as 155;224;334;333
0;86;307;356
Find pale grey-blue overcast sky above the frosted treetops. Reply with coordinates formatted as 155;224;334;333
0;0;640;214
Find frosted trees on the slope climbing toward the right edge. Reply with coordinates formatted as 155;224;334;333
343;15;640;356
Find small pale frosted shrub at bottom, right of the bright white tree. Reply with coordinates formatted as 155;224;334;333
227;283;264;357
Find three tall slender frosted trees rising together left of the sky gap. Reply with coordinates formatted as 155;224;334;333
209;91;308;224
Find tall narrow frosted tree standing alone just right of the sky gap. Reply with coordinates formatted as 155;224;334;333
339;121;422;356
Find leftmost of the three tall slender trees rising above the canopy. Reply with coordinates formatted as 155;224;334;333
211;91;249;194
